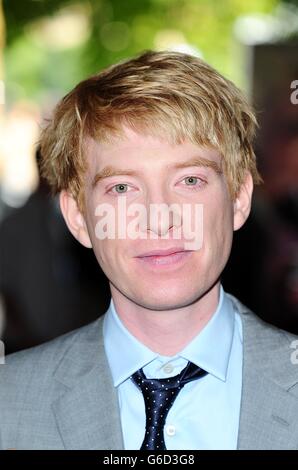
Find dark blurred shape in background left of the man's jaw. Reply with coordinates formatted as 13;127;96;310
0;149;109;353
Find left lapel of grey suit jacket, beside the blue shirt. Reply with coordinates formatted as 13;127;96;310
52;319;123;450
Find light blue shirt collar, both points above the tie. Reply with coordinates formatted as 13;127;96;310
103;286;235;387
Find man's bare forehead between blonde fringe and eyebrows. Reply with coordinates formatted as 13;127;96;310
85;128;222;172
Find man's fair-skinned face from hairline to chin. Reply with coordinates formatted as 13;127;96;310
66;129;250;310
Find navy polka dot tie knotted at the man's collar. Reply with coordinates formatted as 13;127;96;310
131;362;207;450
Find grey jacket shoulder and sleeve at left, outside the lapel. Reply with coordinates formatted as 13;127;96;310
0;318;106;449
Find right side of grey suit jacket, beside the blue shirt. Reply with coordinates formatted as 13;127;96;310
233;299;298;449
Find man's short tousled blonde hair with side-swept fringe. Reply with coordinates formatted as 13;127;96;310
40;51;261;208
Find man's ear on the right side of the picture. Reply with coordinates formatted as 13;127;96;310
234;172;253;230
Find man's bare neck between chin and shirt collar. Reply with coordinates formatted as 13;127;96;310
111;283;220;356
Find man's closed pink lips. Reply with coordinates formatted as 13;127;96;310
136;248;193;268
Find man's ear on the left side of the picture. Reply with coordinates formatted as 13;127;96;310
59;190;92;248
